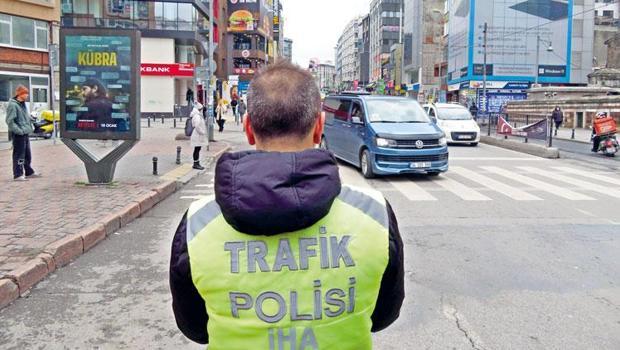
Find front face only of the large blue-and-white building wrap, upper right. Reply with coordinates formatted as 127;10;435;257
473;0;573;82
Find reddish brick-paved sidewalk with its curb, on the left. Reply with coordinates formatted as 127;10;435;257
0;120;228;308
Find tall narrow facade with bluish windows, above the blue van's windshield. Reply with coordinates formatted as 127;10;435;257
369;0;403;81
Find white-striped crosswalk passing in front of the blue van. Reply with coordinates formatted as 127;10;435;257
181;164;620;203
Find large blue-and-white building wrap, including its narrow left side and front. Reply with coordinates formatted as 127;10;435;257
448;0;573;84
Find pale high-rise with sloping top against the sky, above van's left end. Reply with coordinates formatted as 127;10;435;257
335;17;362;90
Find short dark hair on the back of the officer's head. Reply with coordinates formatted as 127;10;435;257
247;60;321;139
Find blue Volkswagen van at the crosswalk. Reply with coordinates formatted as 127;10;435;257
321;92;448;178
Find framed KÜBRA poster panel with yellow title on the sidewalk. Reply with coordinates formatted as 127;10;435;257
60;29;140;140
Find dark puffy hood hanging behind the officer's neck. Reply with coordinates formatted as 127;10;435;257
215;149;341;236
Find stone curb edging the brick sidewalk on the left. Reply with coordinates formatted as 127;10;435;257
0;144;231;309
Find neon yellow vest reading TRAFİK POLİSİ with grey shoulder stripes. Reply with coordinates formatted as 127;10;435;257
187;186;389;350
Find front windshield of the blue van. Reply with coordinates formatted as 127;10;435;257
366;98;430;123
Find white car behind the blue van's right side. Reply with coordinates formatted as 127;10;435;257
424;103;480;146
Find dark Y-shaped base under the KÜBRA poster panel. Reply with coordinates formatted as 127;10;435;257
62;138;138;185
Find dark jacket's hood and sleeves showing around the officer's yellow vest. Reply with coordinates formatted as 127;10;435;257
170;150;405;344
